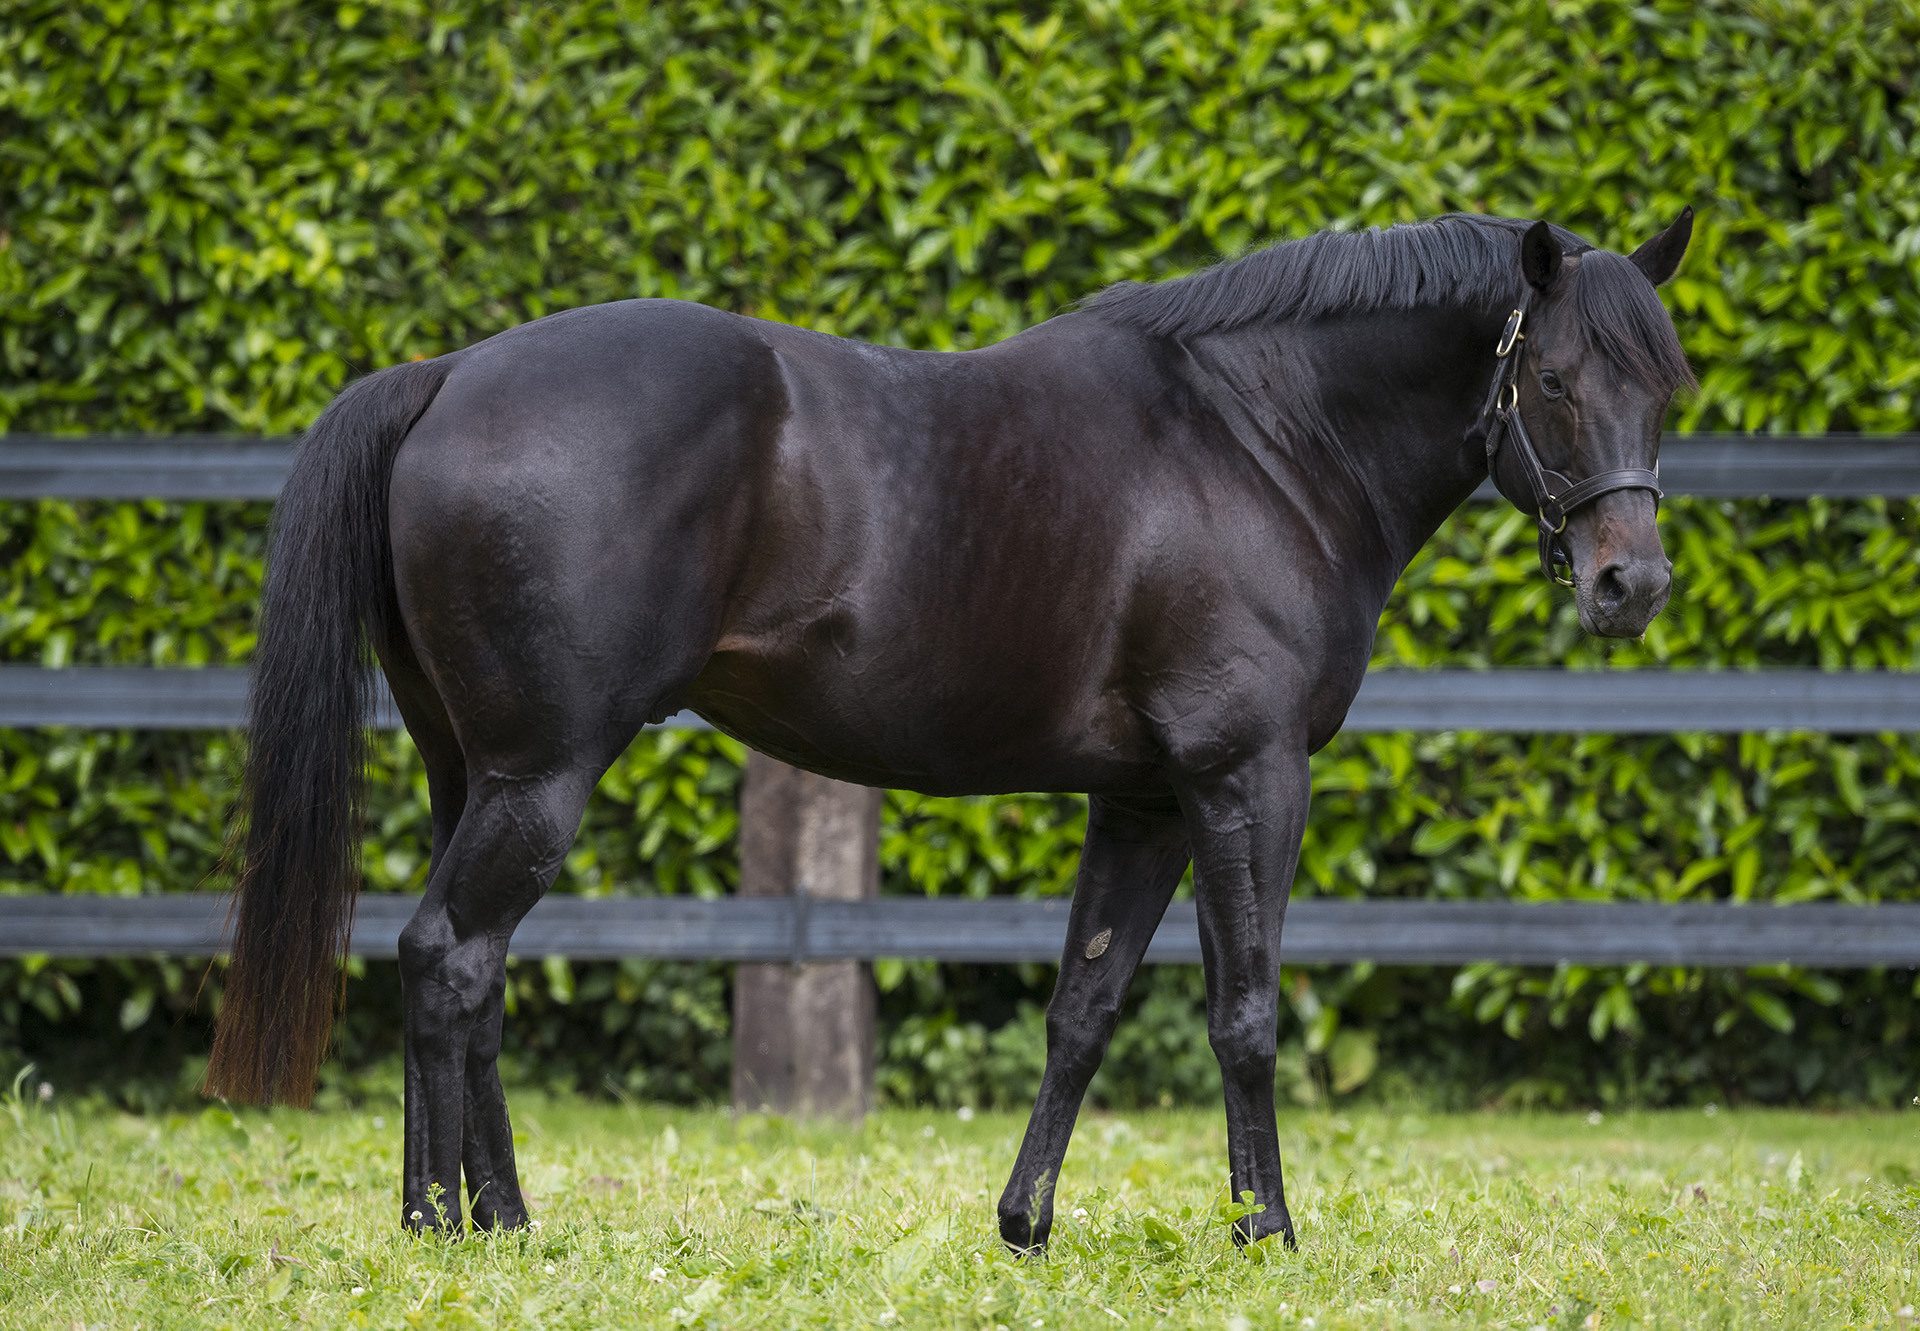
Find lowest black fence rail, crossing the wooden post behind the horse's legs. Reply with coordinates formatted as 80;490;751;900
0;893;1920;968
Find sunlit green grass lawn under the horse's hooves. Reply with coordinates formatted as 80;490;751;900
0;1095;1920;1331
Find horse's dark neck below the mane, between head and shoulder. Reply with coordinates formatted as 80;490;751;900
1192;309;1500;580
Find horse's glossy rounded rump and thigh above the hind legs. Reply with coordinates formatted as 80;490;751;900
390;302;783;770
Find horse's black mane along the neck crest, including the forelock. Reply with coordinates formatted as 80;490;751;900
1087;213;1693;392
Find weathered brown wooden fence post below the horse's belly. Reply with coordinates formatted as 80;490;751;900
733;753;881;1118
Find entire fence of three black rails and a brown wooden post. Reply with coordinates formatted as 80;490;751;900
0;436;1920;1110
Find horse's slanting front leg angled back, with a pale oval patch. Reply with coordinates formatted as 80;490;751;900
1000;799;1187;1252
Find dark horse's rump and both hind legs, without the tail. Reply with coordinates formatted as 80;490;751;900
388;318;785;1227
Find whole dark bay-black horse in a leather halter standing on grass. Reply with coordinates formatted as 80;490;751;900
207;213;1692;1250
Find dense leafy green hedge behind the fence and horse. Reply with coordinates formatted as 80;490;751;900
0;0;1920;1101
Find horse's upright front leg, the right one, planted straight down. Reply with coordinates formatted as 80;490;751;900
1181;745;1308;1246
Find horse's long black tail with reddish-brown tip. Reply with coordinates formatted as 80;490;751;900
204;357;451;1104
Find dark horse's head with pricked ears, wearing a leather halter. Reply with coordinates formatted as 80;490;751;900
1490;209;1693;638
